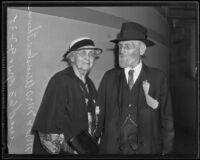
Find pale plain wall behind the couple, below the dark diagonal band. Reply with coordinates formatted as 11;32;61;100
7;7;117;154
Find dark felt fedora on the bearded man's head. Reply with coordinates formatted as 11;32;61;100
111;22;155;47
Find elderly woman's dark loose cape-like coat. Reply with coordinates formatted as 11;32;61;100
31;67;97;153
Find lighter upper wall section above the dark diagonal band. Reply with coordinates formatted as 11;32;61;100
87;6;169;39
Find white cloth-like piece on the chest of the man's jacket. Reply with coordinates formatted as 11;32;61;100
143;80;159;109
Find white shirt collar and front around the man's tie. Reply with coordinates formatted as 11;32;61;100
124;61;142;83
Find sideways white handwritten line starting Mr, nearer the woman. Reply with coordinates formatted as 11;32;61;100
25;7;42;152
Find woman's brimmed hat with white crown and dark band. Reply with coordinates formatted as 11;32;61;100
63;37;103;58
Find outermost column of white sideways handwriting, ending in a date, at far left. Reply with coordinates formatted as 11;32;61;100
7;14;22;153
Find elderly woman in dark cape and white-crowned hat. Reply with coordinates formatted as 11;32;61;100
32;37;102;154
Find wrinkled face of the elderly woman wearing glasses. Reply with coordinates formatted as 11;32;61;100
74;49;95;72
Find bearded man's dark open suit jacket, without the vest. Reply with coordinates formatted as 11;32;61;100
97;64;174;154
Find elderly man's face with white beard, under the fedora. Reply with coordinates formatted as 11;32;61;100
118;40;145;68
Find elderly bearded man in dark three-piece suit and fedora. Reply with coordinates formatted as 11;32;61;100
97;22;174;154
